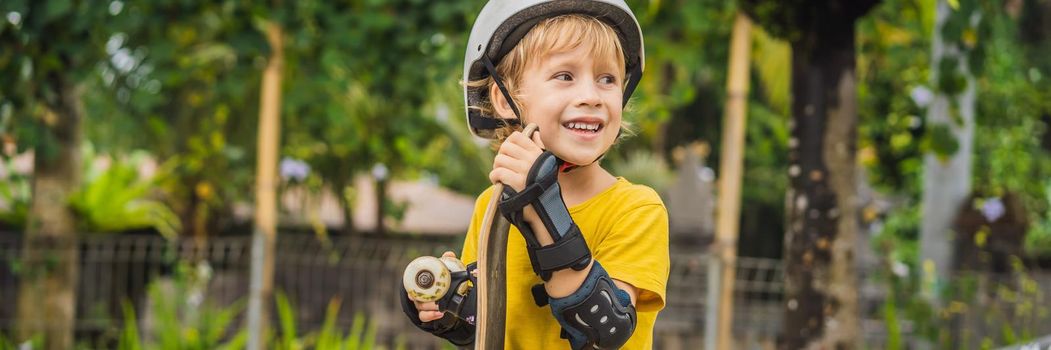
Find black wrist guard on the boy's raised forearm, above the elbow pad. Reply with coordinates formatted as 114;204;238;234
500;151;592;281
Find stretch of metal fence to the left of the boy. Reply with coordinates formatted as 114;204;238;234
0;230;460;348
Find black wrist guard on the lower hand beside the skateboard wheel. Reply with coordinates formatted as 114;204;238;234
398;263;478;346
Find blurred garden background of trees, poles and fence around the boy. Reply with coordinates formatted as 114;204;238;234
0;0;1051;349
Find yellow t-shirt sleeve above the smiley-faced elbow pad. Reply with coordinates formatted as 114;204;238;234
595;202;671;312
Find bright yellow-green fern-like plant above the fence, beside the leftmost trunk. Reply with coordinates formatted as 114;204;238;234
69;146;181;239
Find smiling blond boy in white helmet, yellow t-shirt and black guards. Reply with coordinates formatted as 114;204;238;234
401;0;669;349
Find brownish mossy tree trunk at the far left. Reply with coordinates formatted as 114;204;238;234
16;78;84;349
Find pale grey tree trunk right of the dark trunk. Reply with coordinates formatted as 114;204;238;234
920;0;975;296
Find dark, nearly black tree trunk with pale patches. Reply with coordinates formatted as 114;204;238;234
780;18;860;349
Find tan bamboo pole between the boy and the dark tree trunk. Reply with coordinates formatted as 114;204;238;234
706;13;751;349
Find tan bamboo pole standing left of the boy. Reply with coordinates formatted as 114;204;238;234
247;21;285;350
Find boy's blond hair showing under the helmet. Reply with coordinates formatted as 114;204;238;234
467;14;631;146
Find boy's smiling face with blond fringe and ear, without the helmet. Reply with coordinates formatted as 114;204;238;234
489;16;624;165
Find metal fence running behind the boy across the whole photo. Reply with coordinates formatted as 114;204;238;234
0;233;1051;349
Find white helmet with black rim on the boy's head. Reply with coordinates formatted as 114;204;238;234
463;0;645;139
